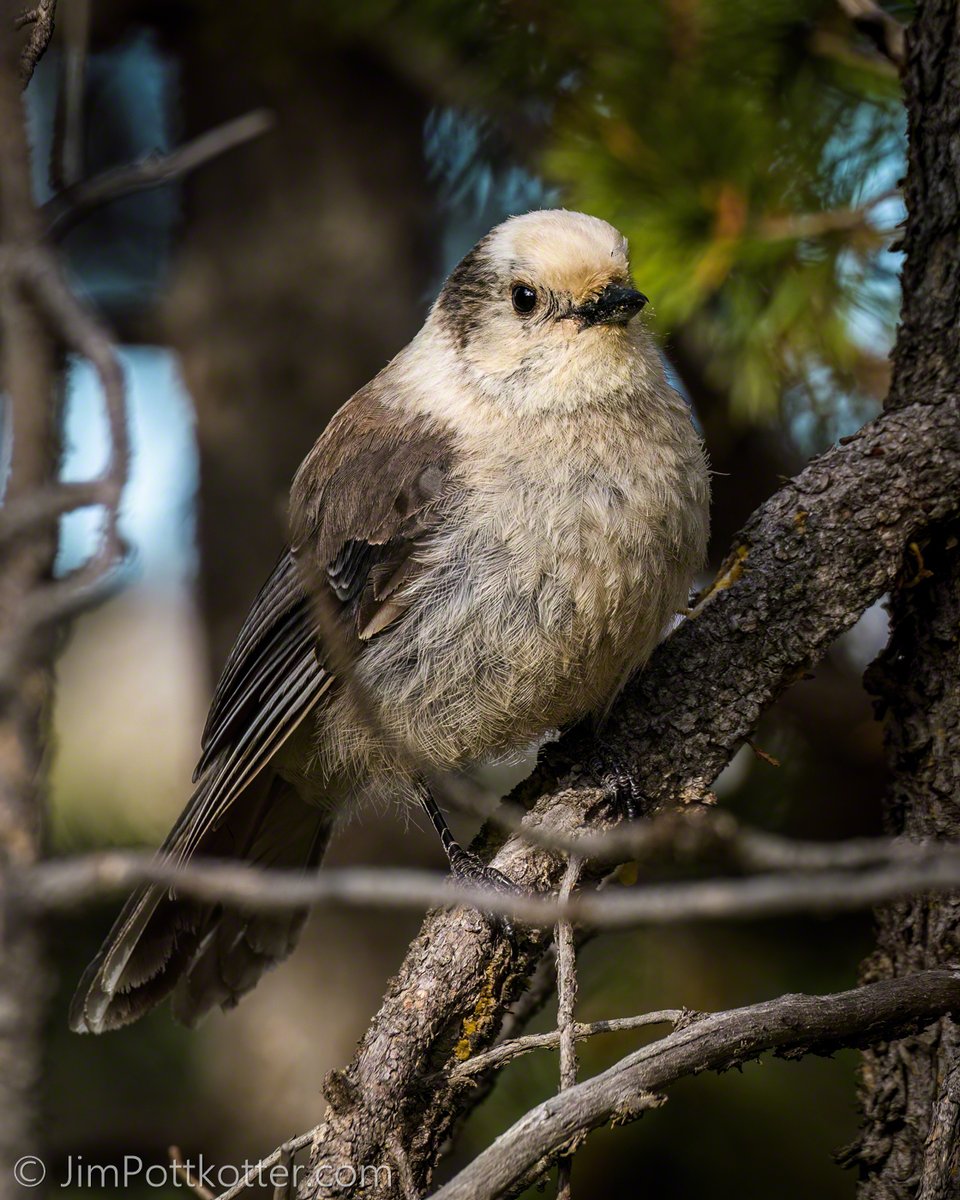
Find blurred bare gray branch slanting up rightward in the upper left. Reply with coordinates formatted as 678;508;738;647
41;108;274;240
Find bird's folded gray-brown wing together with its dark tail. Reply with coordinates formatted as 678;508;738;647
70;396;448;1032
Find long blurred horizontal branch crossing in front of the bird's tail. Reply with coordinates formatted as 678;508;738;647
19;846;960;929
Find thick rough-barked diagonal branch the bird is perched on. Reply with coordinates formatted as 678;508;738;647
290;379;960;1200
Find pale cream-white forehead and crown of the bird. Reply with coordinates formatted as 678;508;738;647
488;209;629;294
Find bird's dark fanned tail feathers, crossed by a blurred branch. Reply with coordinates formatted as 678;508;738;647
70;770;332;1033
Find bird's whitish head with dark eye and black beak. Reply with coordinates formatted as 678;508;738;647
432;209;659;409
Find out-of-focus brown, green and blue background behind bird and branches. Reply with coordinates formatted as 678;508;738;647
20;0;908;1200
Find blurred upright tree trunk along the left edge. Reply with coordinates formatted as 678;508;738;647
0;39;58;1198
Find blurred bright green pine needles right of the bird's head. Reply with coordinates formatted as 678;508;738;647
528;0;902;419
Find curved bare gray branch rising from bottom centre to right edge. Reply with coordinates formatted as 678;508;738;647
433;971;960;1200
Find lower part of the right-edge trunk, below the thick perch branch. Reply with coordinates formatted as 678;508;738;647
858;537;960;1200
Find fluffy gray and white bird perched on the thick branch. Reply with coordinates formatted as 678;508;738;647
70;209;709;1033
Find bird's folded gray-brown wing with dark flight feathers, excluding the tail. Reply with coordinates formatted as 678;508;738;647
186;402;450;858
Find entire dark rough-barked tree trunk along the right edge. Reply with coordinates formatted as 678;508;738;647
850;0;960;1200
